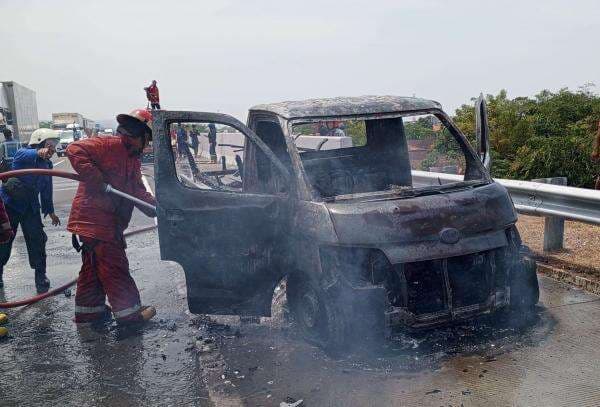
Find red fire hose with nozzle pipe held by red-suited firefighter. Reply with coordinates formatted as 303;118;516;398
0;169;156;308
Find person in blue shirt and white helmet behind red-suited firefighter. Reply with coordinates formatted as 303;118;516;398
0;130;60;293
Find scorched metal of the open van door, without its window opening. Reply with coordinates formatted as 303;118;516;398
153;110;295;315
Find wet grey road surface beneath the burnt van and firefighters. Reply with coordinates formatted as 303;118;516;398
0;159;600;407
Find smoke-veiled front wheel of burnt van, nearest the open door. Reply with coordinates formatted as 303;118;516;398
287;272;347;353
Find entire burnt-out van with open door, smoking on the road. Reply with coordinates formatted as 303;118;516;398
153;96;539;347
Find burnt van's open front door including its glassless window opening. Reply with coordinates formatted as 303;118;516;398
153;110;289;316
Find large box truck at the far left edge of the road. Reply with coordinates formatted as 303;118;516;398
0;81;39;143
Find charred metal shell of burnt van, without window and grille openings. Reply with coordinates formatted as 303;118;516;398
153;97;536;328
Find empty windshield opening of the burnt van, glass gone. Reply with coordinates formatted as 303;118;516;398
292;113;483;198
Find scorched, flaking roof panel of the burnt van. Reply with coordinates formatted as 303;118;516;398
250;96;442;119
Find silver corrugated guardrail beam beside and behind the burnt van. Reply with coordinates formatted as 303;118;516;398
412;171;600;225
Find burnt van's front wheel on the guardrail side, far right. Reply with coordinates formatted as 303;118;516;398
510;257;540;310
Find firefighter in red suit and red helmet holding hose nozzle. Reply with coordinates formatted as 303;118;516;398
67;109;156;324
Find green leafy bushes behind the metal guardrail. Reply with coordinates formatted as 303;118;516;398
453;84;600;188
